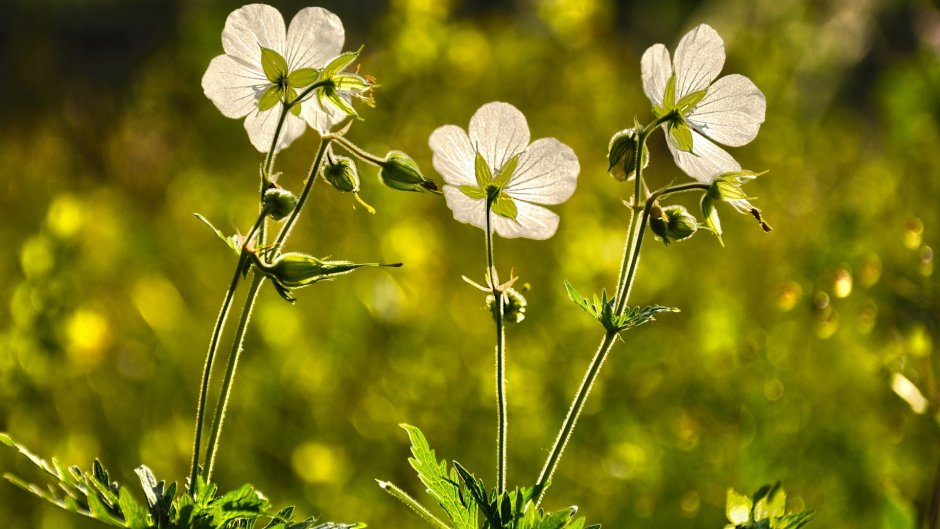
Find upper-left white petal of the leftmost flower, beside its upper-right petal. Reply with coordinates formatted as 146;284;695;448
222;4;286;71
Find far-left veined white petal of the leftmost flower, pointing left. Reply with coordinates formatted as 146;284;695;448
202;55;271;118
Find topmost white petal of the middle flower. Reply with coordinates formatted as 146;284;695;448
468;102;529;173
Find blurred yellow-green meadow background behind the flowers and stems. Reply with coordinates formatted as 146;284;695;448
0;0;940;529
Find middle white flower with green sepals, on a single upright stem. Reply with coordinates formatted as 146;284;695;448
428;102;580;239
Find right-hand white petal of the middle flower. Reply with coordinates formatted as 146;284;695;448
505;138;581;204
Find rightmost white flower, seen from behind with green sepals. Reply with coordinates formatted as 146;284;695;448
641;24;767;183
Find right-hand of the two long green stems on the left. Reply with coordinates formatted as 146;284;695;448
206;136;332;483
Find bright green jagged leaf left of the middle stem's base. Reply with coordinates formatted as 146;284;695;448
400;424;477;529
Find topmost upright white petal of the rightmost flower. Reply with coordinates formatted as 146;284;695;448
675;24;725;101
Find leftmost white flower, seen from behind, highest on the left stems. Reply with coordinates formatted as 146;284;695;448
202;4;346;152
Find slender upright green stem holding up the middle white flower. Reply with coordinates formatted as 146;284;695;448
486;197;509;493
